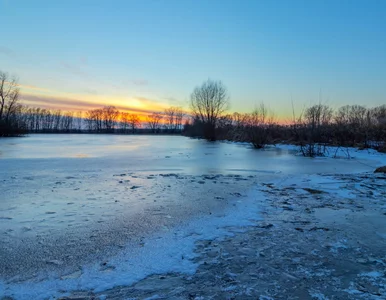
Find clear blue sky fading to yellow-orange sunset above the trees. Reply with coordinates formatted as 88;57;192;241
0;0;386;119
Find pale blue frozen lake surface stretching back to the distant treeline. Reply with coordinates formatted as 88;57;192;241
0;134;376;296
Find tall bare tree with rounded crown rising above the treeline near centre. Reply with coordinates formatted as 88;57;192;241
190;79;229;141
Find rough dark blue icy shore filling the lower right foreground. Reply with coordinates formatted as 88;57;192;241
60;173;386;299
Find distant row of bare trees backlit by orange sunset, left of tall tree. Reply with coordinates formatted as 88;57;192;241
3;105;184;136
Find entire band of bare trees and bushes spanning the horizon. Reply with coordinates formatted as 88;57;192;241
0;71;386;157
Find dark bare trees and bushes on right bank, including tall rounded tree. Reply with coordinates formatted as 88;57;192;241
183;80;386;157
